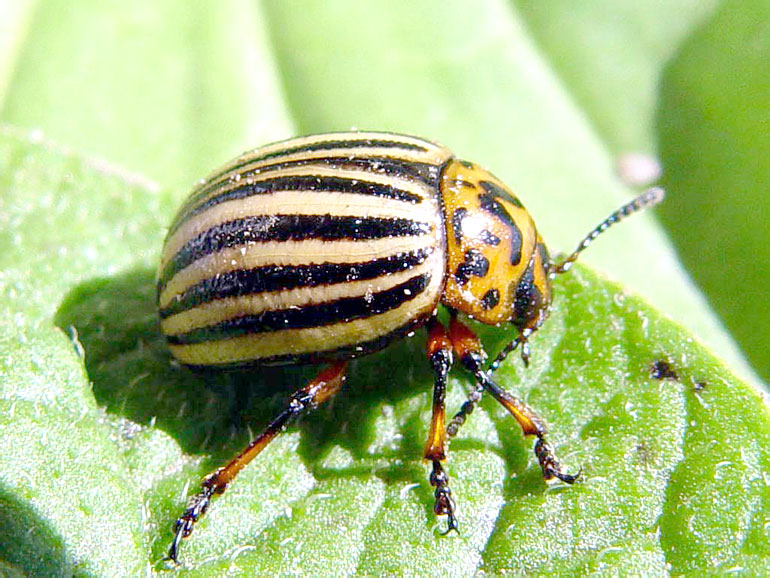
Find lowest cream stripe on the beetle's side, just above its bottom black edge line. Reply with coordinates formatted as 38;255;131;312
169;266;443;365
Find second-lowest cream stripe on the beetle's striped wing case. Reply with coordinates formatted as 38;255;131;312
161;257;436;335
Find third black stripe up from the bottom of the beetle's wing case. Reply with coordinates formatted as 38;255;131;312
160;247;433;319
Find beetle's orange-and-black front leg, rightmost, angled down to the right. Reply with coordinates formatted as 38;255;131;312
447;316;581;484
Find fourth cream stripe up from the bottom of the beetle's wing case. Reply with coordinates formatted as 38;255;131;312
160;191;439;270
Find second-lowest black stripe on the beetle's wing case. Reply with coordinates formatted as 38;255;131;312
167;273;430;345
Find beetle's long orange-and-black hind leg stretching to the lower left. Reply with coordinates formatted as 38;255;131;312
168;361;348;562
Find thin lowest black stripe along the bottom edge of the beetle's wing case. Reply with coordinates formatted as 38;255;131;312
186;317;425;366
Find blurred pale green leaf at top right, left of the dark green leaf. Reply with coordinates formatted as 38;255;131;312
515;0;719;154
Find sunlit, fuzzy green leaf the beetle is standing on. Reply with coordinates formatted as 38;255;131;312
0;126;770;575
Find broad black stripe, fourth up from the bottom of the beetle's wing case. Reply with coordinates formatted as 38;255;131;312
160;214;431;286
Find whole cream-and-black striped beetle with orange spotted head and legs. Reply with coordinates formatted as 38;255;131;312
158;132;663;561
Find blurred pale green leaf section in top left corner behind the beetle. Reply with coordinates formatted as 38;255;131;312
0;0;292;189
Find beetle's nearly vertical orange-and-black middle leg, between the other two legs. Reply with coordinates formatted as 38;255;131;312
424;317;457;533
